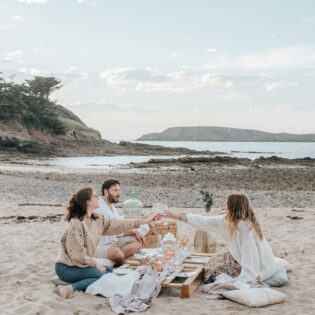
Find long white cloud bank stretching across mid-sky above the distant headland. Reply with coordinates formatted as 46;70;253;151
99;68;299;94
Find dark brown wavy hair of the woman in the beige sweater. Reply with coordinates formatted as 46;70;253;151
65;187;98;222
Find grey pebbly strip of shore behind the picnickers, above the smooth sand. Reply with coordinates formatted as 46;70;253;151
0;160;315;208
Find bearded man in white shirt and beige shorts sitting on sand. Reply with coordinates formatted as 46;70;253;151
95;179;149;265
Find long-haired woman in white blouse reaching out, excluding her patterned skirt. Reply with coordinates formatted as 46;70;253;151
165;194;276;282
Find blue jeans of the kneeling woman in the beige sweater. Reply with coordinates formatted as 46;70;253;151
55;263;113;291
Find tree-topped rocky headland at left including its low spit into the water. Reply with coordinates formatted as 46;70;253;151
0;77;222;158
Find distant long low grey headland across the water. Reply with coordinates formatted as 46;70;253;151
137;127;315;142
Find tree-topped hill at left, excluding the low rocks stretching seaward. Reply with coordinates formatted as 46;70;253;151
0;73;109;155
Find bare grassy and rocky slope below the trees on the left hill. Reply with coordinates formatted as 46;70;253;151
0;105;106;156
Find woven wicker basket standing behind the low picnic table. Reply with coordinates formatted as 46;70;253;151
144;219;177;248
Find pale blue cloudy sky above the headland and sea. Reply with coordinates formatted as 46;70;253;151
0;0;315;140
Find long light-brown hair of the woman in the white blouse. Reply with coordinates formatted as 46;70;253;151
225;194;264;240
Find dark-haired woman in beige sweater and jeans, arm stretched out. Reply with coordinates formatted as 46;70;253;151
55;187;154;298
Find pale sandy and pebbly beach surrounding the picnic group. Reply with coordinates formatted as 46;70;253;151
0;162;315;314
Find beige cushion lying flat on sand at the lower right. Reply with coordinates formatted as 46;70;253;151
222;288;287;307
